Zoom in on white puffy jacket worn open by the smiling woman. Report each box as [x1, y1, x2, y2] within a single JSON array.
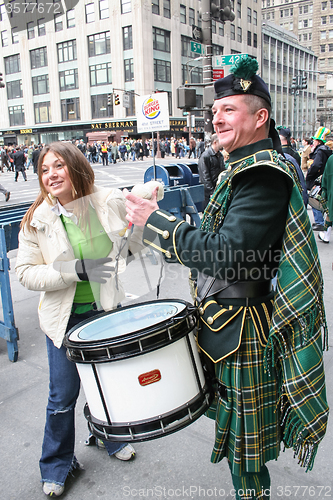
[[15, 188, 143, 348]]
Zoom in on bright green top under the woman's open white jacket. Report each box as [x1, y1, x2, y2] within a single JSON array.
[[60, 205, 112, 304]]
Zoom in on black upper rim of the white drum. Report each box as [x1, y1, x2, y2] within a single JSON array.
[[63, 299, 197, 362]]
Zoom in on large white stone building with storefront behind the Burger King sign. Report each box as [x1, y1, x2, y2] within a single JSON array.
[[0, 0, 261, 144]]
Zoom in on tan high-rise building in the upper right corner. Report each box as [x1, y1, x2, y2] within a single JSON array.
[[262, 0, 333, 130]]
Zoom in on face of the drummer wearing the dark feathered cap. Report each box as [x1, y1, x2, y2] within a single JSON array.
[[212, 95, 267, 153]]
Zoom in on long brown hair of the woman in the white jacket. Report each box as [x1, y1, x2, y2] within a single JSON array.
[[21, 142, 95, 230]]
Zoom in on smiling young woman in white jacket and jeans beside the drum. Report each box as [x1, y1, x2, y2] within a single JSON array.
[[16, 142, 142, 496]]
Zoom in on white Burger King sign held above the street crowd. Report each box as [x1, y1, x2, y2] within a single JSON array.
[[135, 92, 170, 133]]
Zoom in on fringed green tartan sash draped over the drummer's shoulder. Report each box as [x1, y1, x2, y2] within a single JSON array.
[[201, 151, 329, 470]]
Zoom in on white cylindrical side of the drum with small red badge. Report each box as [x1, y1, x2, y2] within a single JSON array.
[[77, 332, 205, 424]]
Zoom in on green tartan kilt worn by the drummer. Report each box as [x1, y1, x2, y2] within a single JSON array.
[[207, 317, 281, 476]]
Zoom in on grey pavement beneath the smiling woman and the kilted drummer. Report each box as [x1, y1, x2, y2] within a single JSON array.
[[0, 220, 333, 500]]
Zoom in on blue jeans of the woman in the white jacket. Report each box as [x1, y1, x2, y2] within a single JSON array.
[[39, 311, 126, 485]]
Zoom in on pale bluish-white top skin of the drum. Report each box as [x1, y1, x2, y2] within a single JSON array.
[[68, 300, 186, 344]]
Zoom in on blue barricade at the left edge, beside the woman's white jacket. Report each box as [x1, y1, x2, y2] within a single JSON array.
[[0, 203, 31, 362]]
